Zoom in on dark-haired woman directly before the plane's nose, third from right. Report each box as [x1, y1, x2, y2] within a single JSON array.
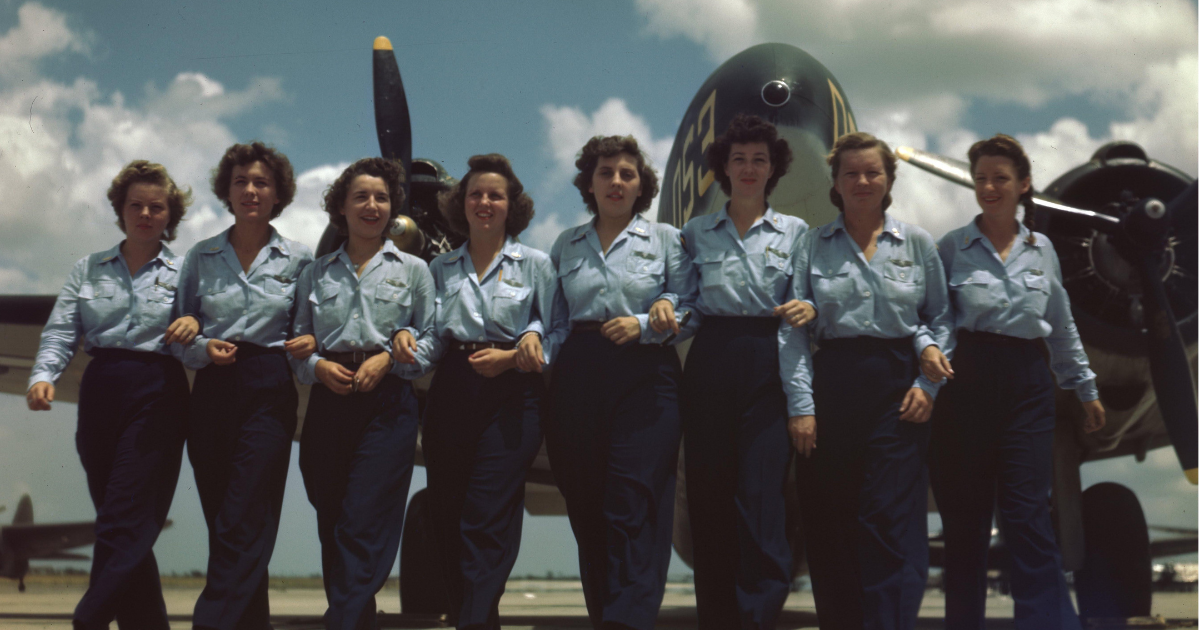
[[680, 114, 808, 630]]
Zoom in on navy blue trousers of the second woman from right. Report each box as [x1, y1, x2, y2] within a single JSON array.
[[796, 337, 930, 630]]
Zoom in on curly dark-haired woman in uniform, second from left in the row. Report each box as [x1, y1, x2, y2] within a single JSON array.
[[179, 142, 312, 630]]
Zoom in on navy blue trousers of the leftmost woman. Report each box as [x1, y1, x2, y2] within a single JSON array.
[[74, 349, 187, 630]]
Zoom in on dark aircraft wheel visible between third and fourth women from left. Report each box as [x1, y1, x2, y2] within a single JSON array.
[[400, 490, 450, 614]]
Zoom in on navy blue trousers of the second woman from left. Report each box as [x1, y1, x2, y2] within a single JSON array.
[[187, 344, 298, 630]]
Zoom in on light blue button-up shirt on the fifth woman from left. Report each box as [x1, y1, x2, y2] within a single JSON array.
[[550, 215, 696, 354]]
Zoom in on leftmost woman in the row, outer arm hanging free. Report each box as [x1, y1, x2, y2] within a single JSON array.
[[25, 160, 196, 630]]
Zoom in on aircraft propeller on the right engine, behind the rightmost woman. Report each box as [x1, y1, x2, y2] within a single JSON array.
[[896, 146, 1198, 485]]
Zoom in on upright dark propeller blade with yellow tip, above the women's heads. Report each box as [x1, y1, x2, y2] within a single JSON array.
[[372, 36, 413, 215]]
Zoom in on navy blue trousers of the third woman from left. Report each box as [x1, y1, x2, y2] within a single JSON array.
[[300, 374, 418, 630]]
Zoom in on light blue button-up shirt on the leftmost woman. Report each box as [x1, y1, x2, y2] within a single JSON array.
[[29, 244, 182, 386]]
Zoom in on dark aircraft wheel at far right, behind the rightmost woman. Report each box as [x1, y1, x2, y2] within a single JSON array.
[[1075, 482, 1151, 619]]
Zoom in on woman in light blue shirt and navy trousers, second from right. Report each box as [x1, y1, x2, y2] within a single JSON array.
[[785, 132, 952, 629]]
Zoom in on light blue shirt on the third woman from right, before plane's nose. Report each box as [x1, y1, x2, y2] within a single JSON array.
[[679, 204, 809, 415]]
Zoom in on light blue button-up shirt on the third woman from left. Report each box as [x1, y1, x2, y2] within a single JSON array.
[[293, 240, 434, 384]]
